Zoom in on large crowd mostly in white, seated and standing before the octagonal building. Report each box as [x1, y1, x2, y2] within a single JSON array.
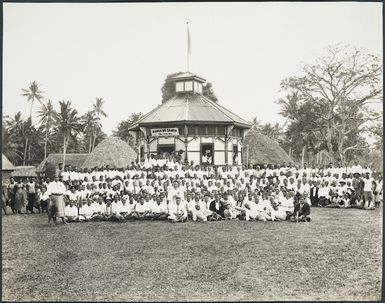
[[3, 155, 383, 223]]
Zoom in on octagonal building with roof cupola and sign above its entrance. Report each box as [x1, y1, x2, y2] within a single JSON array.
[[129, 72, 251, 165]]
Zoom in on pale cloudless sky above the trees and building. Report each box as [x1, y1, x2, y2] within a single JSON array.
[[3, 2, 383, 135]]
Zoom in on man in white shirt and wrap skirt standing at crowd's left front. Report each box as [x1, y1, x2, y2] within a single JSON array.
[[47, 175, 67, 224]]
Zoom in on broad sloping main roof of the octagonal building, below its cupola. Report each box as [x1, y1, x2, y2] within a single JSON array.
[[130, 93, 251, 130]]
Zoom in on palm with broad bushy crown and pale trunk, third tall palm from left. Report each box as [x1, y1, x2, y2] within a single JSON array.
[[54, 101, 80, 167]]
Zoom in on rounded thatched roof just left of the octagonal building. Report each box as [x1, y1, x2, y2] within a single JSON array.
[[82, 137, 137, 168]]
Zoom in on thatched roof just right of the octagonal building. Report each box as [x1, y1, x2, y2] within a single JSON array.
[[242, 132, 293, 164]]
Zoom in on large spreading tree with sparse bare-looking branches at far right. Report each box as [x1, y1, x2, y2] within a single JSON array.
[[278, 46, 382, 162]]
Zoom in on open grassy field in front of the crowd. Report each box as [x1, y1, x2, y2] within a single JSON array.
[[2, 209, 382, 301]]
